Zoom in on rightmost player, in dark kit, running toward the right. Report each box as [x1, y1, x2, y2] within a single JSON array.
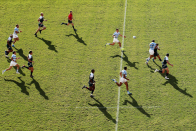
[[154, 53, 173, 80]]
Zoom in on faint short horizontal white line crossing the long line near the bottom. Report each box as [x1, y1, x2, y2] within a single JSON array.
[[76, 106, 160, 109]]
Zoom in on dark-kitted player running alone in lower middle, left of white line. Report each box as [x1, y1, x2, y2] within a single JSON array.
[[82, 69, 95, 98]]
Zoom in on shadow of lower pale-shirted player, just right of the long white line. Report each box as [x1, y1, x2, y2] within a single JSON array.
[[123, 95, 150, 117]]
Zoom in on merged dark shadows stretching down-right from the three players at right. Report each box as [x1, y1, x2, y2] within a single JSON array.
[[148, 62, 193, 98]]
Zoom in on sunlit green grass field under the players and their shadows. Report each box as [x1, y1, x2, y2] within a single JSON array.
[[0, 0, 196, 131]]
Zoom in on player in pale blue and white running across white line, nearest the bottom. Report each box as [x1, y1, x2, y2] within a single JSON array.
[[112, 66, 132, 95]]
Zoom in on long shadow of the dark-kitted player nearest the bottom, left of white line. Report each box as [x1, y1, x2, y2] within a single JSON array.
[[88, 98, 116, 123]]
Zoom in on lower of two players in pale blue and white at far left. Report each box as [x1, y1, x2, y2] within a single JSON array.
[[2, 51, 20, 75]]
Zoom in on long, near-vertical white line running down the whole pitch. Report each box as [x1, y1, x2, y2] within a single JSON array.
[[115, 0, 127, 131]]
